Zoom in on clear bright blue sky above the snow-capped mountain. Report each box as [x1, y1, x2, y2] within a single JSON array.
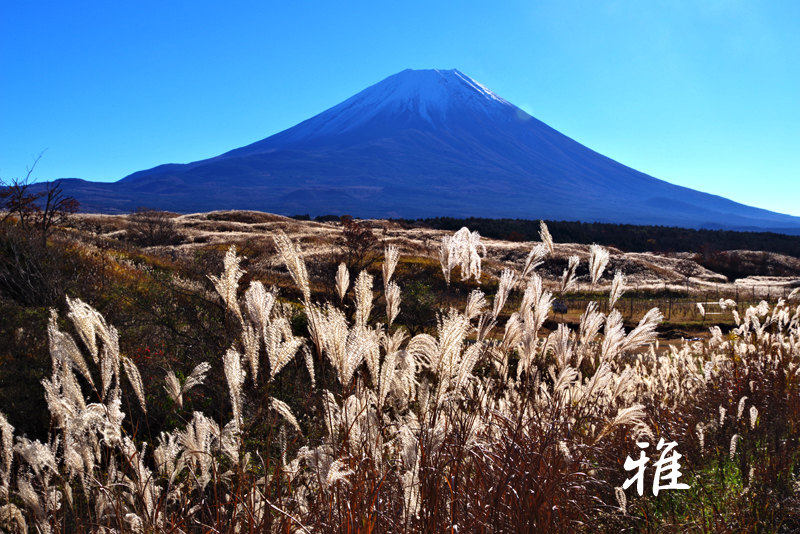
[[0, 0, 800, 216]]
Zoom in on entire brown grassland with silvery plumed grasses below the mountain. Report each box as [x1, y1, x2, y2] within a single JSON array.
[[0, 212, 800, 532]]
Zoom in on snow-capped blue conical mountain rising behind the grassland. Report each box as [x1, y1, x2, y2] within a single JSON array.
[[56, 70, 800, 233]]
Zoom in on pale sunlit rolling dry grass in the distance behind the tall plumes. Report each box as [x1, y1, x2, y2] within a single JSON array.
[[73, 211, 800, 298]]
